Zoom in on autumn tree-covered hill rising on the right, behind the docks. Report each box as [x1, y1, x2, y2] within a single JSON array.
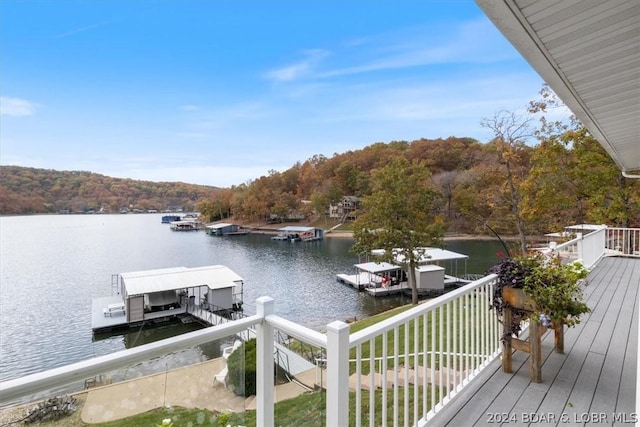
[[198, 86, 640, 241]]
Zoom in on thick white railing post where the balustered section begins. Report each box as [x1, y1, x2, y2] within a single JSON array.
[[326, 321, 349, 426]]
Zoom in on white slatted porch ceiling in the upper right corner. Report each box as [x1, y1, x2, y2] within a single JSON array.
[[475, 0, 640, 175]]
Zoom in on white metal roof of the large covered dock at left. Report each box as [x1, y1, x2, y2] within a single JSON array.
[[120, 265, 242, 295]]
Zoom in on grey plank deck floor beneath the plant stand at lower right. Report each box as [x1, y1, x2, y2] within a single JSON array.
[[429, 258, 640, 427]]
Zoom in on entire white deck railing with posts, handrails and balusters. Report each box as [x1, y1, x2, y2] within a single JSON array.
[[0, 228, 640, 426]]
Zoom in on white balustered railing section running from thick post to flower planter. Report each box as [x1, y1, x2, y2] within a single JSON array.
[[344, 275, 501, 426]]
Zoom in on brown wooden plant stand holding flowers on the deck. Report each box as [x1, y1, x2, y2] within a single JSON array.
[[502, 287, 564, 383]]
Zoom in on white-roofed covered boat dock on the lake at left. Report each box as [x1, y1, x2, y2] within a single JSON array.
[[91, 265, 243, 332]]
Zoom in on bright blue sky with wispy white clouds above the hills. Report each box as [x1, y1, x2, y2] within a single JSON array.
[[0, 0, 542, 187]]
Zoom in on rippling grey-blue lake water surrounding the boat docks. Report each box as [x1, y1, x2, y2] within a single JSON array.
[[0, 214, 510, 381]]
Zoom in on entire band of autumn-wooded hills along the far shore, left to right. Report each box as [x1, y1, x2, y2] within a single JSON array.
[[0, 89, 640, 236]]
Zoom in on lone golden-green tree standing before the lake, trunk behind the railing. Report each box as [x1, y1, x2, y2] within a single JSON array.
[[351, 157, 444, 304]]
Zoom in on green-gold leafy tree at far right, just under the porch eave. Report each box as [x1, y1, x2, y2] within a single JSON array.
[[524, 85, 640, 229]]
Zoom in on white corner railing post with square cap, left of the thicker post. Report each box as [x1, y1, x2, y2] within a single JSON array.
[[256, 297, 274, 427]]
